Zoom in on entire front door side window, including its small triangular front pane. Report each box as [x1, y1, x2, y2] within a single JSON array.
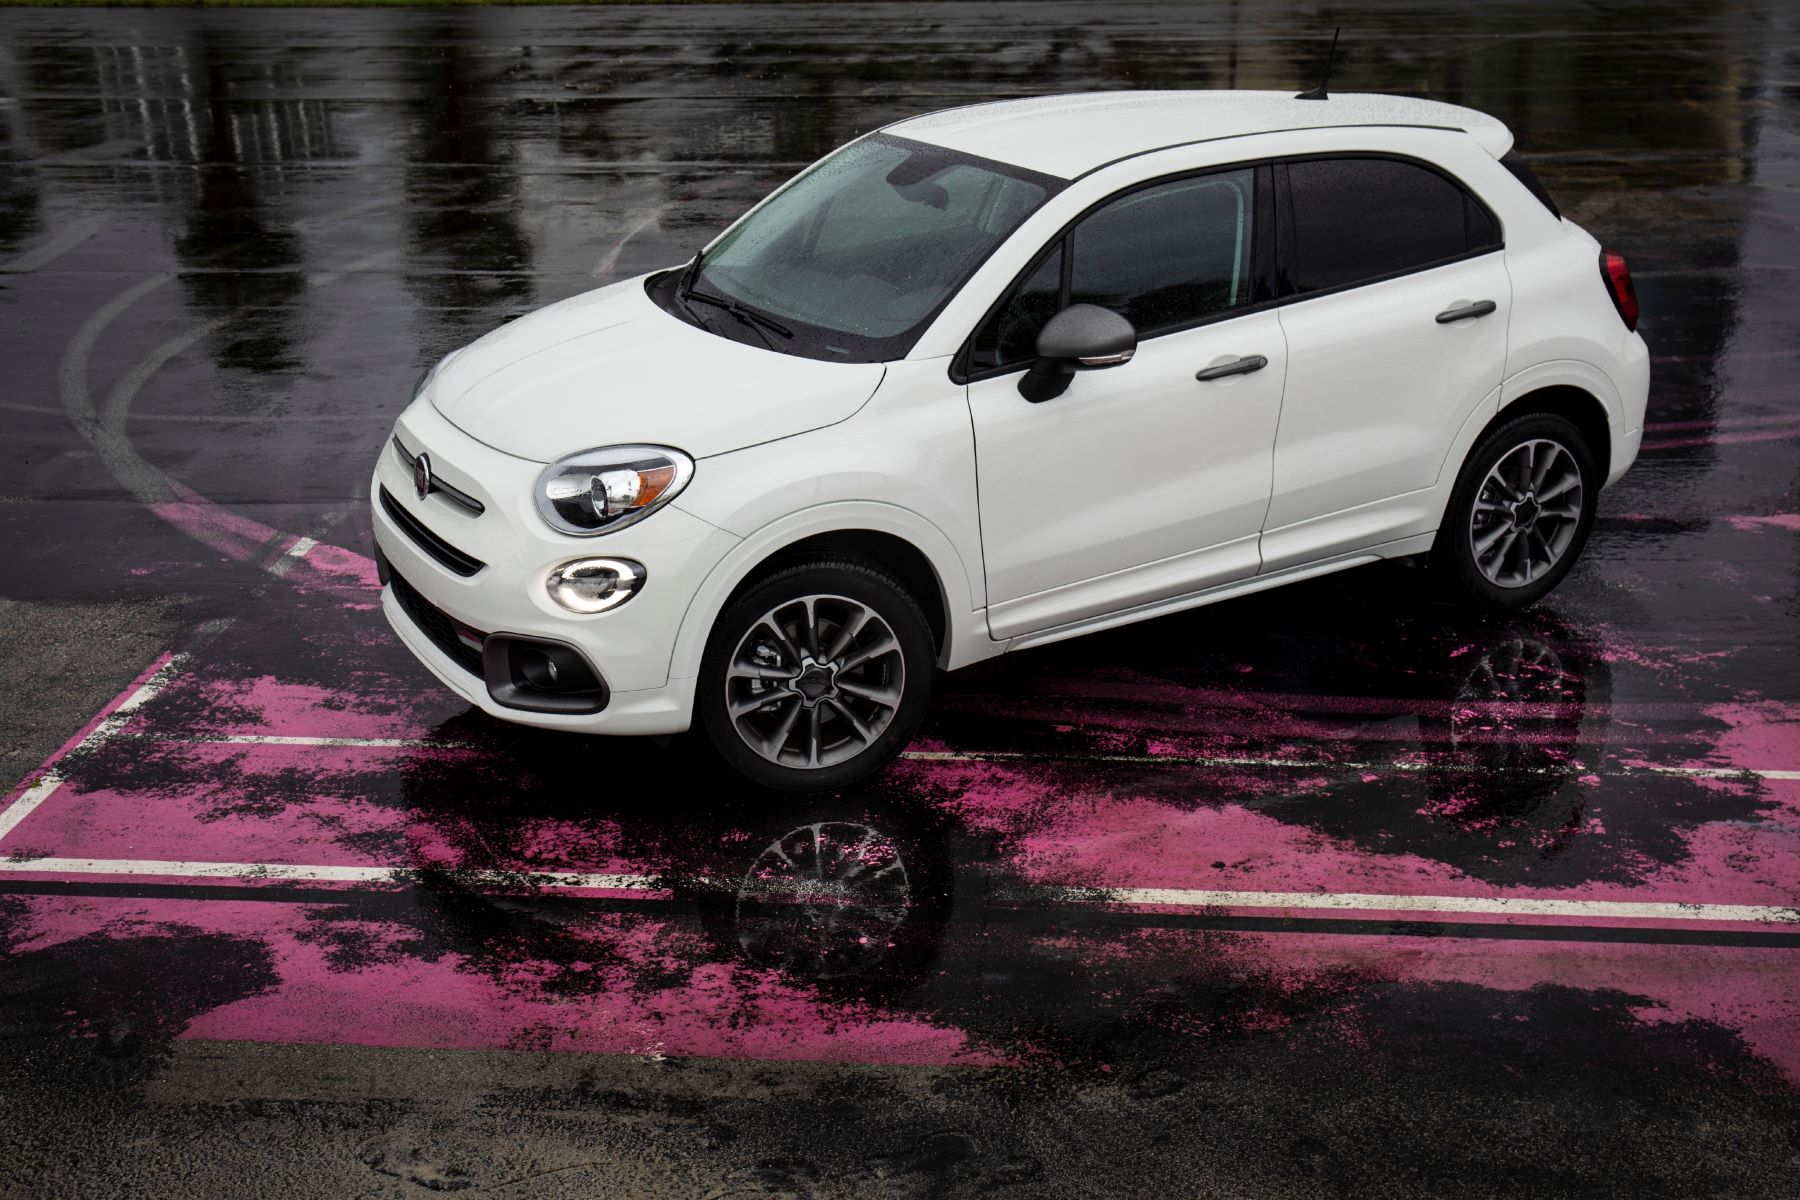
[[968, 169, 1255, 371]]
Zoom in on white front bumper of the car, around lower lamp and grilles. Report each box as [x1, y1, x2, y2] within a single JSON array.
[[371, 399, 738, 734]]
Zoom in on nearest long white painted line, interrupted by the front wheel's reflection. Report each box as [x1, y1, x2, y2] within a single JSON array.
[[0, 858, 1800, 925]]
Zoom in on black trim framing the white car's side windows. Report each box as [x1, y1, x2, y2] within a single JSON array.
[[950, 149, 1507, 385]]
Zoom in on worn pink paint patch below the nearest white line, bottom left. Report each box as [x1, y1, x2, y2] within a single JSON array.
[[14, 898, 1008, 1067]]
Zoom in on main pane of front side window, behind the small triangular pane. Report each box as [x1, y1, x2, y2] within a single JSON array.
[[1069, 171, 1255, 336]]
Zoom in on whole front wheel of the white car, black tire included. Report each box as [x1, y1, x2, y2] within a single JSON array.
[[695, 558, 936, 793]]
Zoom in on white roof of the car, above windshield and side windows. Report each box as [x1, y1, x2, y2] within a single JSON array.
[[887, 92, 1512, 180]]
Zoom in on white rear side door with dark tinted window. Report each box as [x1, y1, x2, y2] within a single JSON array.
[[1262, 155, 1512, 572]]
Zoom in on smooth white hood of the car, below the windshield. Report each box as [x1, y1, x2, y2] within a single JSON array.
[[428, 279, 884, 462]]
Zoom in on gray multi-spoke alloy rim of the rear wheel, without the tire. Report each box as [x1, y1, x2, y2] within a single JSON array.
[[1469, 437, 1584, 588]]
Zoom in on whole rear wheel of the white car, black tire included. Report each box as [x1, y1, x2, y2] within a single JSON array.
[[1431, 412, 1602, 608]]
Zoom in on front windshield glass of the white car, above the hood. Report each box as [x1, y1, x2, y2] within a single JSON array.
[[691, 135, 1058, 362]]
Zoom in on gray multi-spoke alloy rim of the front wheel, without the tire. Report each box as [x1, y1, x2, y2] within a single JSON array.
[[724, 594, 905, 770]]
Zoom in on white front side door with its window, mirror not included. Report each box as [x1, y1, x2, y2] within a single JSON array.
[[968, 167, 1287, 639]]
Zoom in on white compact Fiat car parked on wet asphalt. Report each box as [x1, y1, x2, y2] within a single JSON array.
[[373, 92, 1649, 790]]
